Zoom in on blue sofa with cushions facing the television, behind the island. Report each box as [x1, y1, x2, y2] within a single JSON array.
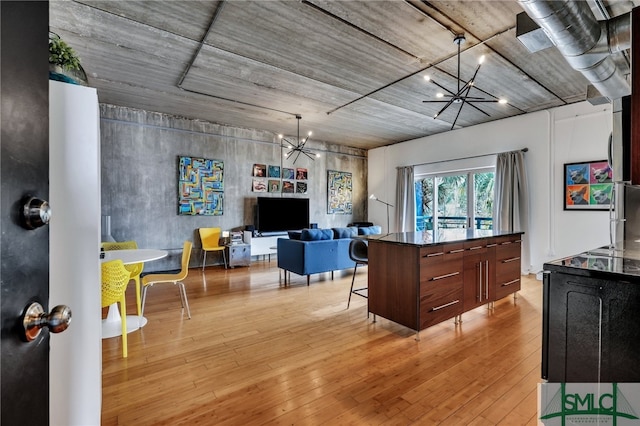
[[278, 226, 381, 285]]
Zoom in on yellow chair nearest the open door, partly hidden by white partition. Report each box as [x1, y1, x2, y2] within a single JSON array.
[[101, 259, 131, 358]]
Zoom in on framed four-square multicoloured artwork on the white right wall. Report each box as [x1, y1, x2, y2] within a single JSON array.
[[564, 160, 613, 210]]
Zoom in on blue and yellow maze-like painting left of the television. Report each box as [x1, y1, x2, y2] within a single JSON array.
[[178, 157, 224, 216]]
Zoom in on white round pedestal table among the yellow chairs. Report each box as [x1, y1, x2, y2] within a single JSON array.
[[100, 249, 169, 339]]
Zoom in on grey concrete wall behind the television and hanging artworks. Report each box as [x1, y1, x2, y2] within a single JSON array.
[[101, 104, 368, 271]]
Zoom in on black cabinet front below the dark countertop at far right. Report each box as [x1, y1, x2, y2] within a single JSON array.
[[542, 265, 640, 383]]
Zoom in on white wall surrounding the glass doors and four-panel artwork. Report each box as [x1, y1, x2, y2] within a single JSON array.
[[368, 102, 612, 273]]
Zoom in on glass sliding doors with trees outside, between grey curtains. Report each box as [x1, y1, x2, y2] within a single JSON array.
[[415, 168, 495, 231]]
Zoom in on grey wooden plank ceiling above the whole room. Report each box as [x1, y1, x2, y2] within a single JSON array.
[[50, 0, 634, 149]]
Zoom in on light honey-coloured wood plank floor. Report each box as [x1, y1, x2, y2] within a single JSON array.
[[102, 260, 542, 426]]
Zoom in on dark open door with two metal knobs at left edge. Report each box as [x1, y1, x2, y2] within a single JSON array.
[[0, 1, 49, 425]]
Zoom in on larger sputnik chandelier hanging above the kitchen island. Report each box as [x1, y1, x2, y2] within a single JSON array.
[[422, 34, 507, 130]]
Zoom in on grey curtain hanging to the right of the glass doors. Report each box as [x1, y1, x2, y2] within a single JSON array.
[[493, 151, 529, 271]]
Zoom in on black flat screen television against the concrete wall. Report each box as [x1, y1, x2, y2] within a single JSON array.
[[256, 197, 309, 233]]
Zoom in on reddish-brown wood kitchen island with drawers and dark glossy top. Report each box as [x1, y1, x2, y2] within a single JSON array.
[[367, 229, 523, 339]]
